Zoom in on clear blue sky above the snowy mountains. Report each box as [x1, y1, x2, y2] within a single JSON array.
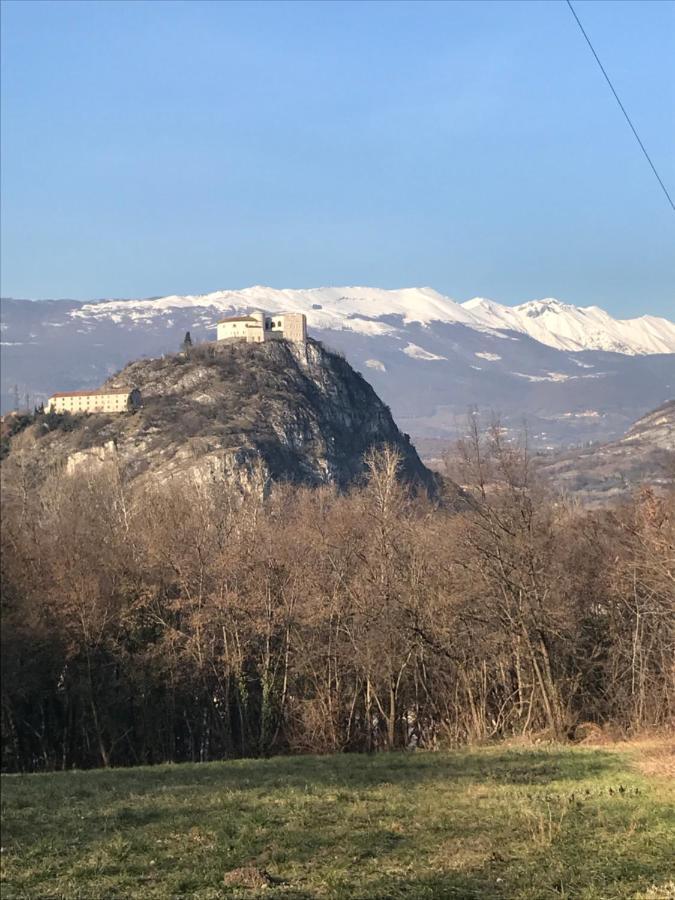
[[2, 0, 675, 318]]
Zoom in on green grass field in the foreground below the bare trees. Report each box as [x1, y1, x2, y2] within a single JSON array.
[[2, 746, 675, 900]]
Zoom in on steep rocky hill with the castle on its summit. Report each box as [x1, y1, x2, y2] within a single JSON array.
[[6, 340, 435, 490]]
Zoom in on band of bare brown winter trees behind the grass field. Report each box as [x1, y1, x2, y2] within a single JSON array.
[[2, 426, 675, 771]]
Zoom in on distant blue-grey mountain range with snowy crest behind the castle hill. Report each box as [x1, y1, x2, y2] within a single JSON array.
[[2, 287, 675, 447]]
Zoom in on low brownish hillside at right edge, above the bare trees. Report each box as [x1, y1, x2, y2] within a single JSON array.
[[539, 400, 675, 506]]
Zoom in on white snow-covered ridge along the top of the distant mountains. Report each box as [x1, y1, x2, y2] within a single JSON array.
[[70, 285, 675, 355]]
